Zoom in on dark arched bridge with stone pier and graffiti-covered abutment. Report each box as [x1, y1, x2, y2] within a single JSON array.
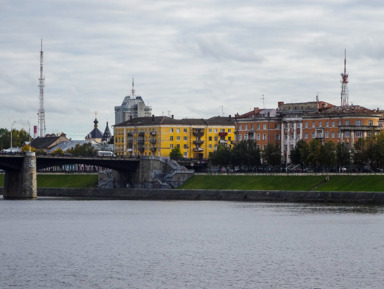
[[0, 152, 193, 199]]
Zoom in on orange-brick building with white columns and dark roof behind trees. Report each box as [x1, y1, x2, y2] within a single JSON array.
[[235, 101, 382, 163]]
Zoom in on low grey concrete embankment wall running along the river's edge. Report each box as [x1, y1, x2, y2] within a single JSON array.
[[32, 188, 384, 205]]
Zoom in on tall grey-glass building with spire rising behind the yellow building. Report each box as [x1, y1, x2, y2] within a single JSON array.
[[115, 80, 152, 124]]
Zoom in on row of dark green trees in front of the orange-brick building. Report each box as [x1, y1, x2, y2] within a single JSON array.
[[209, 134, 384, 171]]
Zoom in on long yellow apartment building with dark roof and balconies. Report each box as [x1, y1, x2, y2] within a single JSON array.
[[114, 116, 235, 159]]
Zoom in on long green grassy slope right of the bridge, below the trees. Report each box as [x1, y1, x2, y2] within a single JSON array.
[[180, 175, 384, 192]]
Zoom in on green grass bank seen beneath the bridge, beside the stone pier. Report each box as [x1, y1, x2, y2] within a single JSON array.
[[0, 174, 98, 188]]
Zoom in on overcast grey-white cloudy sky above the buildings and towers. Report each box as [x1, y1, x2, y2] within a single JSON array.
[[0, 0, 384, 140]]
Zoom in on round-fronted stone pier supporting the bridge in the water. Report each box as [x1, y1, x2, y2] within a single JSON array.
[[3, 152, 37, 199]]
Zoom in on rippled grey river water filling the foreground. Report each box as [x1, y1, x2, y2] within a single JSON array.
[[0, 197, 384, 289]]
